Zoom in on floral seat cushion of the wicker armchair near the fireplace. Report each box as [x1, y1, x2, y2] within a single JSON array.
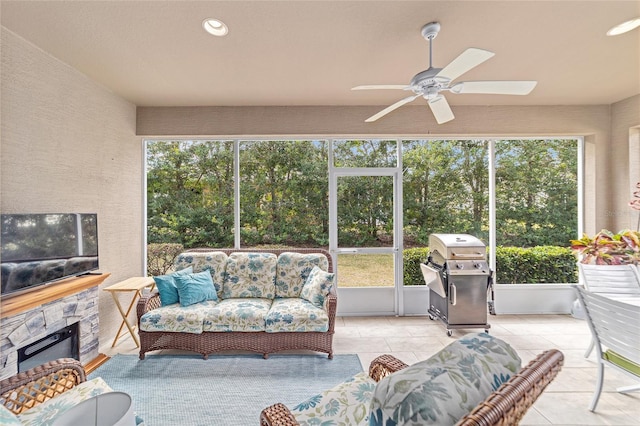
[[18, 377, 113, 426]]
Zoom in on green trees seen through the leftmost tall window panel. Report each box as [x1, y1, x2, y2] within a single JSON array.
[[147, 141, 233, 248]]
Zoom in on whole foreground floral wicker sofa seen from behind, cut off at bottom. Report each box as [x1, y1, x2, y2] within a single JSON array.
[[260, 333, 564, 426]]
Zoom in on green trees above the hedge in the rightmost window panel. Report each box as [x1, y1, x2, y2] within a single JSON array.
[[496, 140, 578, 247]]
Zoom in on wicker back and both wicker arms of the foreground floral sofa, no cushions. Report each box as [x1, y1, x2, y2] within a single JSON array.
[[260, 349, 564, 426]]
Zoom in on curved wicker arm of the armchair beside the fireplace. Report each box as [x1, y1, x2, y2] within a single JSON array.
[[0, 358, 87, 414]]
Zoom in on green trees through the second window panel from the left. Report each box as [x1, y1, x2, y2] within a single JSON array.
[[240, 141, 329, 246]]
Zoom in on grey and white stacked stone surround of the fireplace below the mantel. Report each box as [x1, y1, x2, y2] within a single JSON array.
[[0, 286, 99, 380]]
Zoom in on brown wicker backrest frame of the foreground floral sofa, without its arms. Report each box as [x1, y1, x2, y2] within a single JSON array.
[[456, 349, 564, 426]]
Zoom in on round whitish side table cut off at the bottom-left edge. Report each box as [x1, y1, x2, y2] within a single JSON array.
[[53, 392, 136, 426]]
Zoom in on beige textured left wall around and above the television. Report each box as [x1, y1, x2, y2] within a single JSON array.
[[0, 27, 143, 352]]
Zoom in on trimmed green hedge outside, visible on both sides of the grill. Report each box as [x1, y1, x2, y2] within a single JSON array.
[[402, 246, 578, 285]]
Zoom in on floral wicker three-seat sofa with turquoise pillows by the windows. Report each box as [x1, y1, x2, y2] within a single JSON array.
[[137, 249, 337, 359]]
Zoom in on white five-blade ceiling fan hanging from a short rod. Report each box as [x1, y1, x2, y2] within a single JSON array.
[[351, 22, 538, 124]]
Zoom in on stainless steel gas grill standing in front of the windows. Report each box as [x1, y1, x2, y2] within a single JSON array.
[[420, 234, 493, 336]]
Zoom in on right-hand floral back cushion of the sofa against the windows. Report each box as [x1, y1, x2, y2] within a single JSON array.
[[276, 252, 329, 297]]
